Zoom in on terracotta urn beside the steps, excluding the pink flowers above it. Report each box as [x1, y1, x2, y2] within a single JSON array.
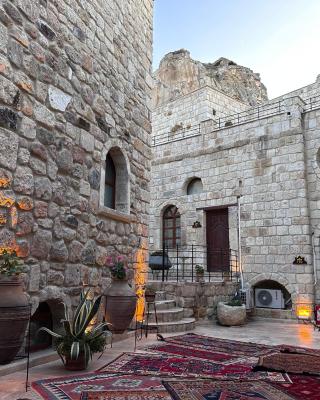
[[105, 279, 137, 333]]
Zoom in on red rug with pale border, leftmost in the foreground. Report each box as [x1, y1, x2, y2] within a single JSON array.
[[32, 372, 170, 400]]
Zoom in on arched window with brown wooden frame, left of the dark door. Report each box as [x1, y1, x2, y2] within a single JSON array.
[[163, 206, 181, 247]]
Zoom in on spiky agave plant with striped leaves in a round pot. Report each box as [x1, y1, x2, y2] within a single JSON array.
[[38, 289, 111, 371]]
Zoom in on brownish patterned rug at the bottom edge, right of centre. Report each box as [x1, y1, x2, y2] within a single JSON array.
[[163, 380, 294, 400]]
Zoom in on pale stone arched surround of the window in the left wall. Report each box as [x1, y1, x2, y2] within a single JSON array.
[[100, 139, 131, 214]]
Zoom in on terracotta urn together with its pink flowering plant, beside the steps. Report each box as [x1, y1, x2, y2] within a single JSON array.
[[105, 256, 137, 333]]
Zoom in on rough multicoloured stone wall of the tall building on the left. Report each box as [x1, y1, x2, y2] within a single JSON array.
[[0, 0, 153, 309]]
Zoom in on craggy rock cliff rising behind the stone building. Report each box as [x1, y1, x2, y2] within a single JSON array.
[[153, 49, 268, 107]]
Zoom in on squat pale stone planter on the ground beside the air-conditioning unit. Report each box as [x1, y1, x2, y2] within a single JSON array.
[[217, 299, 247, 326]]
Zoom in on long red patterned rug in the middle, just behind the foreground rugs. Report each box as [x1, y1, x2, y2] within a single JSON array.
[[100, 353, 290, 382]]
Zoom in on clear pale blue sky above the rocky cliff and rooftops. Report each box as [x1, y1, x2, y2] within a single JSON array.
[[154, 0, 320, 98]]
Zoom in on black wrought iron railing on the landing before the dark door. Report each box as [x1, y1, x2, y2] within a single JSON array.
[[148, 245, 240, 282]]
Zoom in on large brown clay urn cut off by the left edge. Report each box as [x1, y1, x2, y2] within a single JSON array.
[[0, 275, 30, 364]]
